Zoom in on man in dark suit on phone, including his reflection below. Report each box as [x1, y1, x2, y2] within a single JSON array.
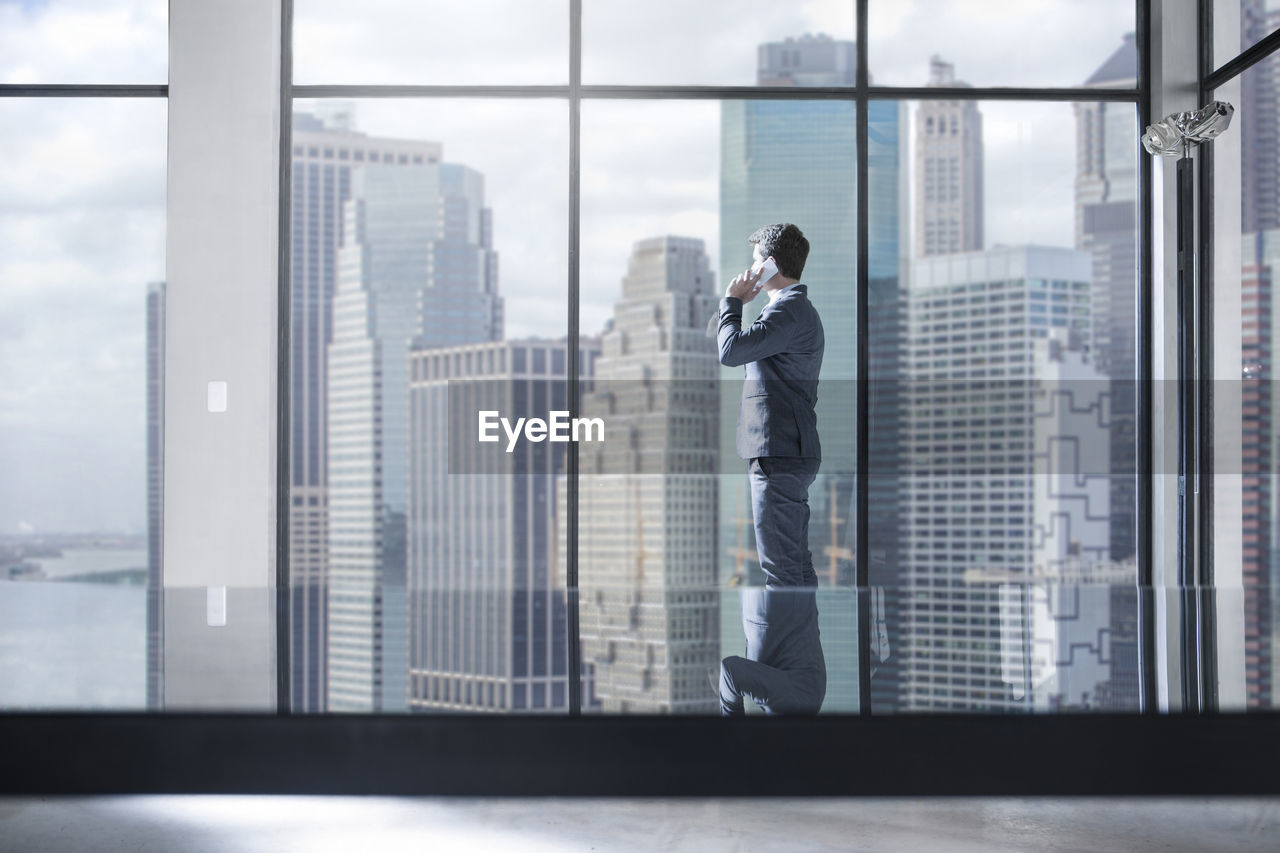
[[716, 224, 827, 716]]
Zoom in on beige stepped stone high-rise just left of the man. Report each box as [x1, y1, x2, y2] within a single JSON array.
[[576, 237, 721, 713]]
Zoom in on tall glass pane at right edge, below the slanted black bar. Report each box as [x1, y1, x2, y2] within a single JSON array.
[[1213, 54, 1280, 710]]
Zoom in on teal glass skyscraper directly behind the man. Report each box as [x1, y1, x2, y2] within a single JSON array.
[[719, 35, 908, 711]]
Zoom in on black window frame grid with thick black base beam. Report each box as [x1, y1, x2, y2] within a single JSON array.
[[10, 0, 1280, 795]]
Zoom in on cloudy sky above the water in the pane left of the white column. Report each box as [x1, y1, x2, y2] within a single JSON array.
[[0, 94, 166, 530]]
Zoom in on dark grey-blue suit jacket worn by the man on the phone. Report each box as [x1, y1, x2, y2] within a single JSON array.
[[708, 284, 826, 459]]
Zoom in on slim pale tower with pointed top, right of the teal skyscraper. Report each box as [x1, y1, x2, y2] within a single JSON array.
[[915, 55, 983, 255]]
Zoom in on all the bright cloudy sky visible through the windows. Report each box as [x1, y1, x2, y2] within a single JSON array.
[[0, 0, 1134, 534]]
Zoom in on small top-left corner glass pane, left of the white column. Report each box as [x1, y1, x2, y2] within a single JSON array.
[[0, 0, 169, 83]]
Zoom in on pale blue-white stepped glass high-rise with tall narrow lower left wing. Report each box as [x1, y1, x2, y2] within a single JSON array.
[[326, 154, 502, 711]]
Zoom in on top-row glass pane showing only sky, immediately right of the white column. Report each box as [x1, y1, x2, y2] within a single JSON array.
[[293, 0, 568, 86]]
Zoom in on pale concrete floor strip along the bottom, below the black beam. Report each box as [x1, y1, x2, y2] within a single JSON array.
[[0, 795, 1280, 853]]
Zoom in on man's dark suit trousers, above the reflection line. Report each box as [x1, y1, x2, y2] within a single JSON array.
[[748, 456, 822, 587]]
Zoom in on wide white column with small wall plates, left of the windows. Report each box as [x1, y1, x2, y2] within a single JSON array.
[[164, 0, 280, 710]]
